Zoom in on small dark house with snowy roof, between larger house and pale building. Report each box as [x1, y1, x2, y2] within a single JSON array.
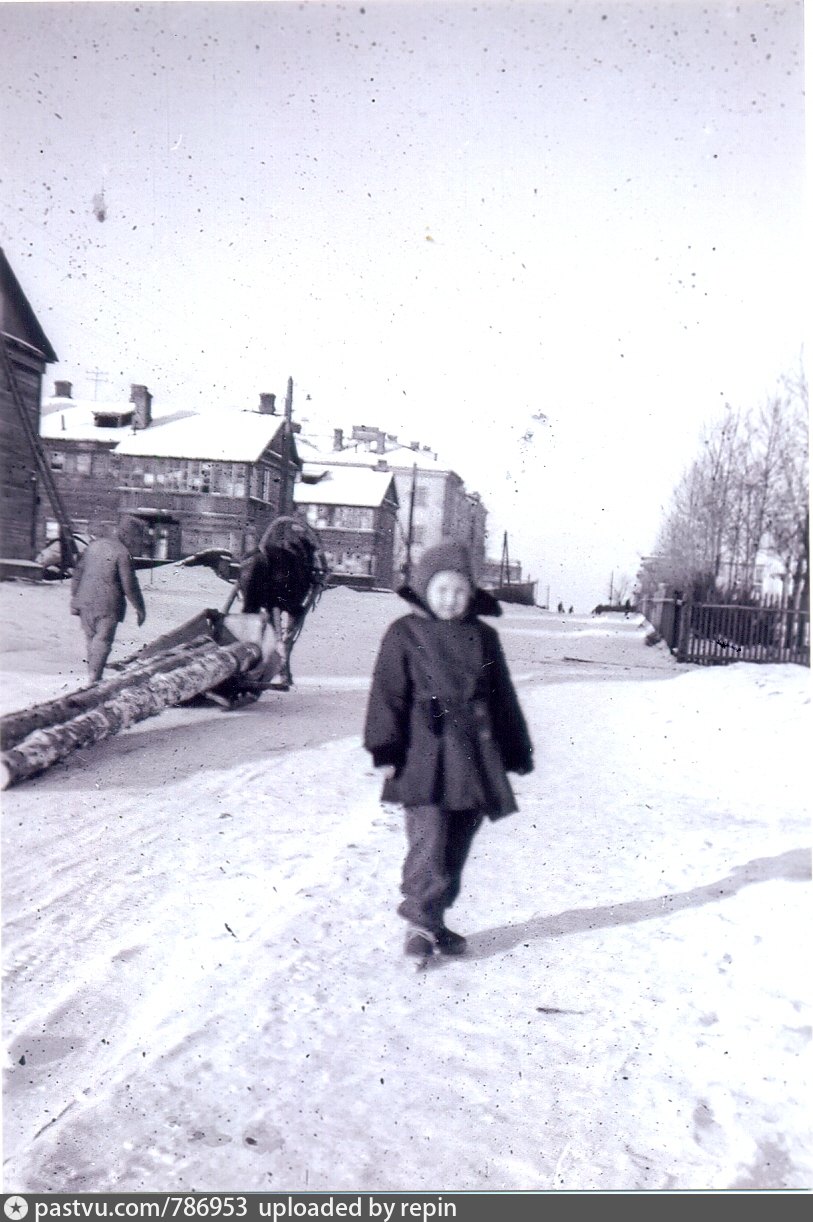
[[293, 464, 399, 588]]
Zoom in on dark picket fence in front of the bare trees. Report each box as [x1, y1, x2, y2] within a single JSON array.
[[638, 594, 811, 666]]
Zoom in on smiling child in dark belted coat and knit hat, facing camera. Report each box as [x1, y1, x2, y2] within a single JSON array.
[[364, 540, 533, 957]]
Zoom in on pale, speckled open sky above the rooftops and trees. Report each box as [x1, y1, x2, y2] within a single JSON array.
[[0, 0, 807, 610]]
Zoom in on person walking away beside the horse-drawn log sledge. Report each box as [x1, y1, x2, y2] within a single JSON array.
[[71, 517, 147, 683]]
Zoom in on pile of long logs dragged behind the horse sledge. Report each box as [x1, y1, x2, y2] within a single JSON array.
[[0, 635, 260, 789]]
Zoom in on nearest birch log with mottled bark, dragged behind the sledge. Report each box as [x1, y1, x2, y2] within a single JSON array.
[[0, 642, 260, 789]]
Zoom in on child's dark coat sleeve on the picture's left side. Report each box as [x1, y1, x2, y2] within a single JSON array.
[[364, 622, 412, 769]]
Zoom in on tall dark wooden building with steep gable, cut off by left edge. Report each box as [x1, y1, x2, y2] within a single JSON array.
[[0, 249, 56, 561]]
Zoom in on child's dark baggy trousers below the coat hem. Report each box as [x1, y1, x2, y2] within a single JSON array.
[[399, 807, 483, 932]]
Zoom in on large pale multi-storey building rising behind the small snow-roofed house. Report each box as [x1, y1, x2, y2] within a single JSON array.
[[301, 424, 488, 579]]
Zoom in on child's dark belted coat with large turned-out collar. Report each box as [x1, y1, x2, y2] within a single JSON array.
[[364, 587, 533, 819]]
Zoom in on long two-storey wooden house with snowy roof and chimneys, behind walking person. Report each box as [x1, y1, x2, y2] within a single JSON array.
[[40, 384, 301, 560]]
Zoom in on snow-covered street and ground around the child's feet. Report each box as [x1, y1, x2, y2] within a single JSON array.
[[0, 569, 813, 1193]]
